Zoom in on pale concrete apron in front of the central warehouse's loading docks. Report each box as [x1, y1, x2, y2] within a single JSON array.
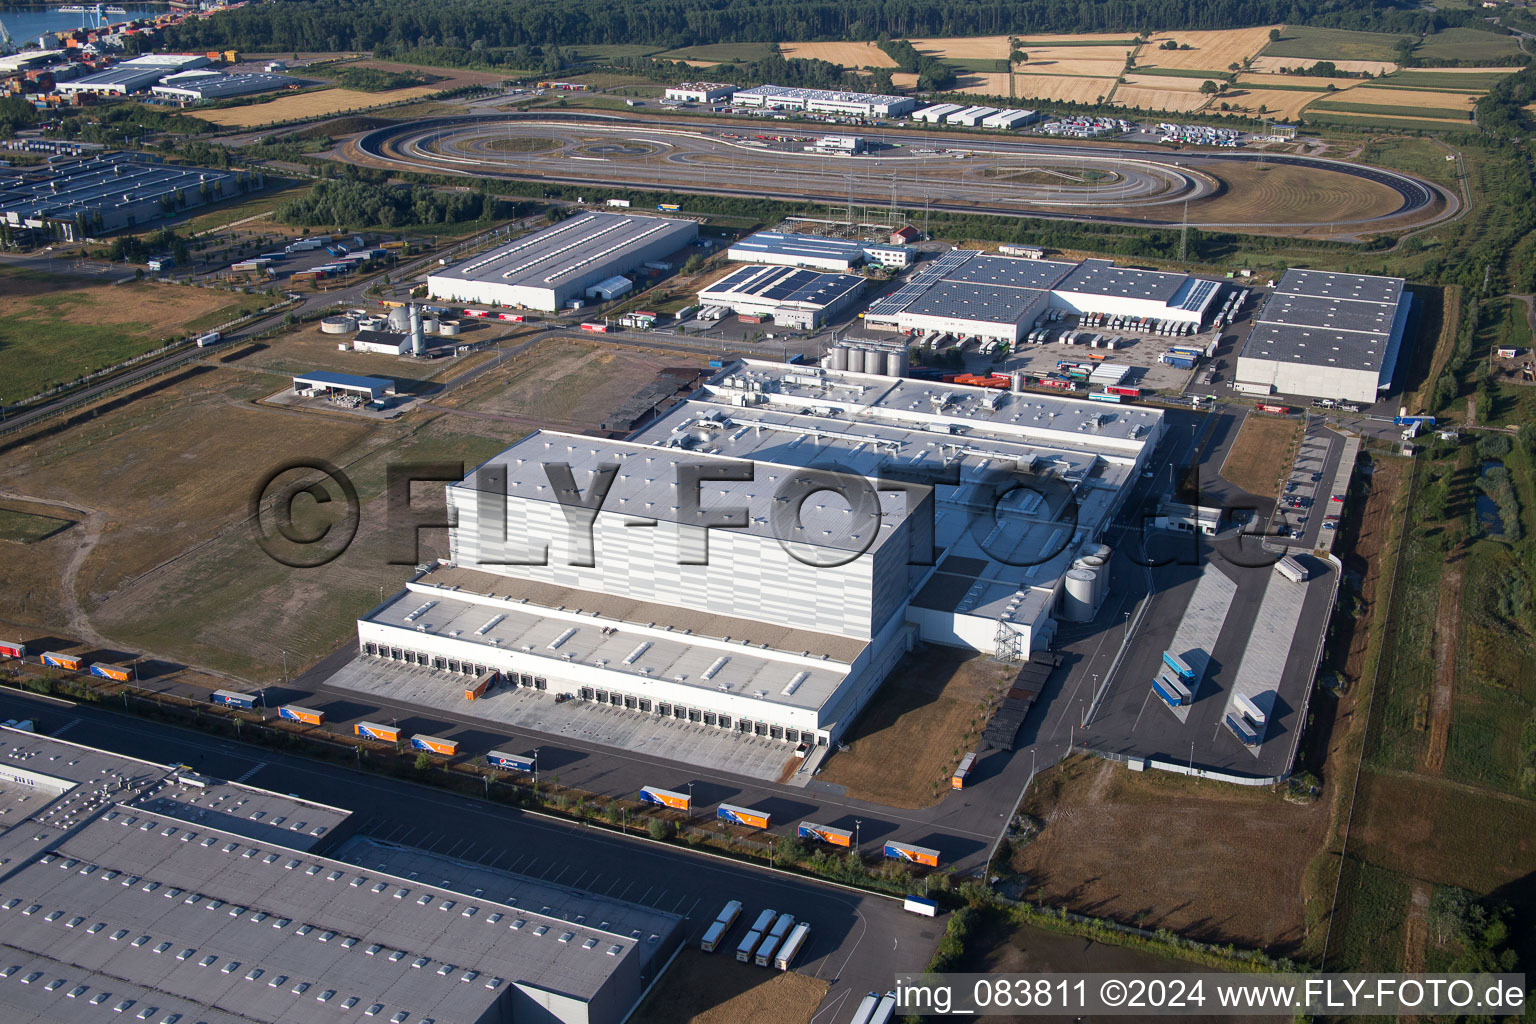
[[326, 659, 793, 781]]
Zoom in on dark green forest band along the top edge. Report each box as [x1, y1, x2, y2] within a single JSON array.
[[166, 0, 1481, 52]]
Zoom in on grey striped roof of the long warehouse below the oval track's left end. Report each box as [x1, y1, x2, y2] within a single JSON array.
[[432, 213, 699, 289]]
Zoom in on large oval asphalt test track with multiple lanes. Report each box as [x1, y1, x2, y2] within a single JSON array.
[[353, 114, 1459, 227]]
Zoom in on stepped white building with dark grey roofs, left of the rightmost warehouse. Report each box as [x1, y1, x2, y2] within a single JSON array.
[[865, 249, 1221, 344]]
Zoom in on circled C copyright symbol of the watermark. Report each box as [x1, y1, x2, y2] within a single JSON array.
[[250, 459, 362, 570]]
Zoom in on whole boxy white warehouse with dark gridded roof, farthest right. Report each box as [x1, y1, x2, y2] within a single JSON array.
[[1236, 270, 1412, 402]]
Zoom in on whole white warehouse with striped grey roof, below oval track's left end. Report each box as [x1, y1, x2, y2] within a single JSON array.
[[427, 213, 699, 312]]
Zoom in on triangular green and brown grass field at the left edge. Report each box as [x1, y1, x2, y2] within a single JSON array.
[[0, 270, 254, 402]]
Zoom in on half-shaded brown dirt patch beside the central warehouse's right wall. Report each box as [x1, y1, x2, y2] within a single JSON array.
[[817, 645, 1018, 808]]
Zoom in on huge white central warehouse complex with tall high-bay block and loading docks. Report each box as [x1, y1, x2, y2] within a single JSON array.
[[344, 361, 1163, 745]]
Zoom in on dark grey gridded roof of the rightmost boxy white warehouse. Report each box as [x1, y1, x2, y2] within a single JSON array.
[[1240, 270, 1407, 376]]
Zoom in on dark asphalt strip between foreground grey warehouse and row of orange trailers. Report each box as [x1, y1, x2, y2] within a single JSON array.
[[0, 688, 945, 1024]]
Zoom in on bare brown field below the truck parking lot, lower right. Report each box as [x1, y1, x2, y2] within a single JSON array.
[[1012, 757, 1327, 953]]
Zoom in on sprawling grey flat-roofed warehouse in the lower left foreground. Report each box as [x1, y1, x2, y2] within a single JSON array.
[[0, 728, 682, 1024]]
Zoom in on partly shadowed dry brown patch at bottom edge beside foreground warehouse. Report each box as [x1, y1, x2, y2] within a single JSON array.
[[630, 946, 831, 1024]]
